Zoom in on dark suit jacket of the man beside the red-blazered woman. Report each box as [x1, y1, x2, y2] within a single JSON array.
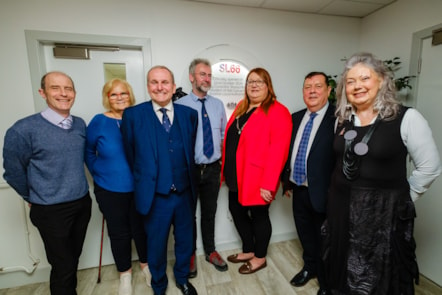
[[281, 104, 336, 213]]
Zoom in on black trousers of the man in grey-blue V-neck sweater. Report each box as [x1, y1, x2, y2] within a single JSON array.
[[30, 193, 92, 295]]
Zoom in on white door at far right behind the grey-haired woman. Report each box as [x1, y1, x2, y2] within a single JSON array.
[[415, 38, 442, 285]]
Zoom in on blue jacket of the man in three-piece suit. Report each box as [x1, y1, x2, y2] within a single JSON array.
[[121, 101, 198, 215]]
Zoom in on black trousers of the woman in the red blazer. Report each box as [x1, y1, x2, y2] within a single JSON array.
[[229, 191, 272, 258]]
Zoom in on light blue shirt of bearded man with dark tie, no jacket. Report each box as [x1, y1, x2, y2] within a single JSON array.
[[175, 92, 227, 164]]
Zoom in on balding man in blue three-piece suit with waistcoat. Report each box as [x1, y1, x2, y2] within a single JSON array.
[[121, 66, 198, 295]]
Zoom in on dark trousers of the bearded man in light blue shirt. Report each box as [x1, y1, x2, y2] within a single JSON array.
[[193, 161, 221, 254]]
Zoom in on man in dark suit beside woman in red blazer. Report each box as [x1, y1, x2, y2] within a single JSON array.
[[282, 72, 335, 295]]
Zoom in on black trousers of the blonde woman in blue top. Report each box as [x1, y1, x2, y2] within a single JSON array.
[[94, 183, 147, 272]]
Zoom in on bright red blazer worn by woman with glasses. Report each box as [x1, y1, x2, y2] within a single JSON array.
[[221, 101, 292, 206]]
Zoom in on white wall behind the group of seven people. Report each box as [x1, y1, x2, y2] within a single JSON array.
[[0, 0, 442, 288]]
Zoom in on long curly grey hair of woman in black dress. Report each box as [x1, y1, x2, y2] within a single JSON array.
[[335, 52, 401, 123]]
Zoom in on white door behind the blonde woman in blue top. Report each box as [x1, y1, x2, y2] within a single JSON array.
[[44, 45, 146, 269]]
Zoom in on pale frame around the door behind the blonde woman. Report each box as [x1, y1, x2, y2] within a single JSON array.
[[25, 30, 152, 112]]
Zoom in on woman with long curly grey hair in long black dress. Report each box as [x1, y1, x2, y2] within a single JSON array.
[[323, 53, 441, 295]]
